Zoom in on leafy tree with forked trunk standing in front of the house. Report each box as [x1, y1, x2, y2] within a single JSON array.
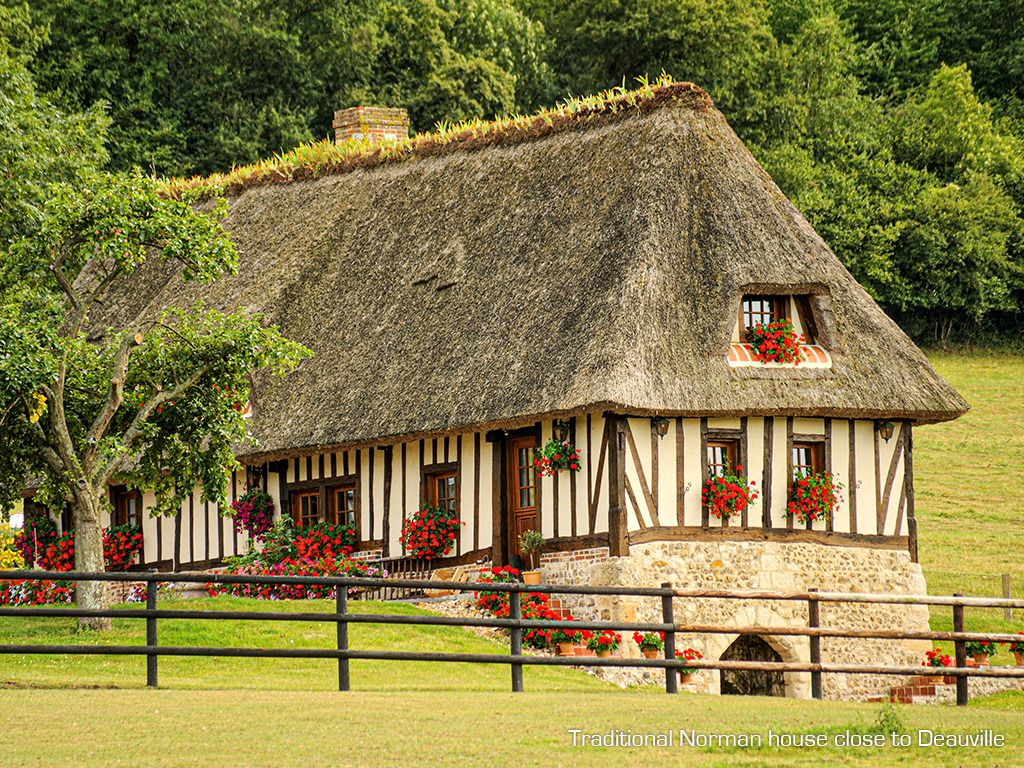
[[0, 173, 308, 629]]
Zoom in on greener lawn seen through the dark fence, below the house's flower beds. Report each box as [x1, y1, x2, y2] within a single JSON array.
[[0, 597, 609, 696]]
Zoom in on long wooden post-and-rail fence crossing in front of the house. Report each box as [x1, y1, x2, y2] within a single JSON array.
[[0, 568, 1024, 706]]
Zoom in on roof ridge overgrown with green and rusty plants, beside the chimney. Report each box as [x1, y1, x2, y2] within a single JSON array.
[[164, 72, 714, 203]]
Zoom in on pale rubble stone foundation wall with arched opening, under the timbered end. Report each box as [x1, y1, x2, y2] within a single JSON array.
[[543, 542, 931, 700]]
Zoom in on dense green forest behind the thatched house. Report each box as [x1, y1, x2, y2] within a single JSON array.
[[0, 0, 1024, 346]]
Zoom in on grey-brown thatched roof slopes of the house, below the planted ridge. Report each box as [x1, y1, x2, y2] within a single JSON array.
[[90, 82, 968, 457]]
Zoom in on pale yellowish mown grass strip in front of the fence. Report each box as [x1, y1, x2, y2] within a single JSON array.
[[0, 683, 1024, 768]]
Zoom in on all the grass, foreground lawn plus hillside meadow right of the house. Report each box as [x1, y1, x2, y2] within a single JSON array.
[[0, 353, 1024, 768]]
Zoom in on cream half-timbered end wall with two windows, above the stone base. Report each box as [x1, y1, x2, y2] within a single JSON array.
[[622, 417, 912, 538]]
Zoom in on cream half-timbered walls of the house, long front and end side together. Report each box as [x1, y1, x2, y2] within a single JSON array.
[[253, 414, 913, 559]]
